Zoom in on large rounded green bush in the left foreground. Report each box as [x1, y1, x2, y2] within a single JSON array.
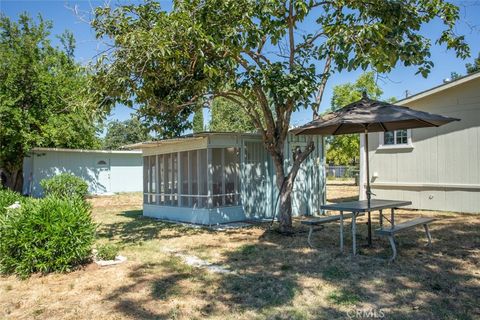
[[0, 197, 96, 278]]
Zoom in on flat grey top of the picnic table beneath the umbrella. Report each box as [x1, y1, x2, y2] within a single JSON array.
[[320, 199, 412, 212]]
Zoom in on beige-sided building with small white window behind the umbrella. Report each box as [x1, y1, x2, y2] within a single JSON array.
[[360, 73, 480, 213]]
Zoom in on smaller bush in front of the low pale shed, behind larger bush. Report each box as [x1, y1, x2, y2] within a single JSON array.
[[40, 173, 88, 199]]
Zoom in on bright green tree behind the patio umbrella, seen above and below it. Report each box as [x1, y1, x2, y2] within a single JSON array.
[[327, 72, 395, 165]]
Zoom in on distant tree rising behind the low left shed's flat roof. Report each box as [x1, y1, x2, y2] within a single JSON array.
[[103, 117, 152, 150]]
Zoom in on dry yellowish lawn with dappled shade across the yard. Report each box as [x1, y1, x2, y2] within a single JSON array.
[[0, 183, 480, 319]]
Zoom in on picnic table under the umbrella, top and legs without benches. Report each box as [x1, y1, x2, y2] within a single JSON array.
[[320, 199, 412, 256]]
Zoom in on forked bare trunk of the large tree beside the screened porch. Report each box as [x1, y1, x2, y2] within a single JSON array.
[[272, 141, 315, 233]]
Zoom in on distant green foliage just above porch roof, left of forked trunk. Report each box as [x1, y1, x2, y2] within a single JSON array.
[[209, 98, 256, 132]]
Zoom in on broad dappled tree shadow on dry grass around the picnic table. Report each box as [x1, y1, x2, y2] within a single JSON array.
[[103, 211, 480, 319]]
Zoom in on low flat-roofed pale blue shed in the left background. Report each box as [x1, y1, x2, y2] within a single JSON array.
[[23, 148, 142, 197]]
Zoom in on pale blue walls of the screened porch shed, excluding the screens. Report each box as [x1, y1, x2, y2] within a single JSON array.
[[144, 134, 325, 225]]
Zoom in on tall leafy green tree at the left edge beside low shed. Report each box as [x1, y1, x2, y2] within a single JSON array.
[[0, 14, 99, 191]]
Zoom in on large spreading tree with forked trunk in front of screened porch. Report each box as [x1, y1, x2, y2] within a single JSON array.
[[92, 0, 468, 231]]
